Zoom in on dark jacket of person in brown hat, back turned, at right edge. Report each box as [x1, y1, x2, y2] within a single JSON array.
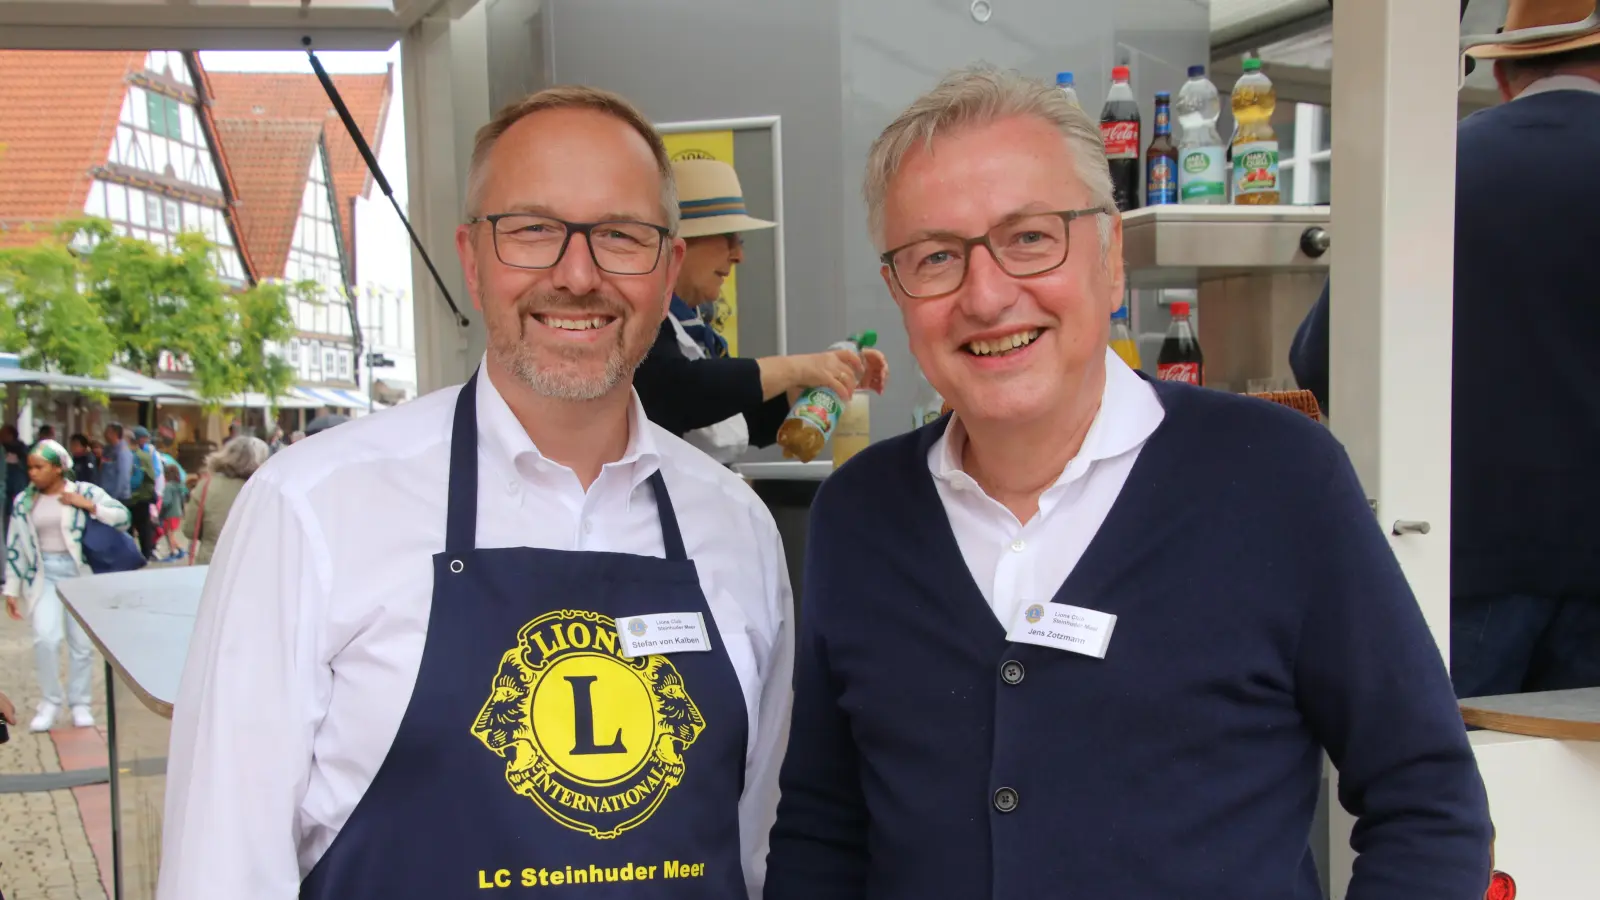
[[1290, 91, 1600, 597]]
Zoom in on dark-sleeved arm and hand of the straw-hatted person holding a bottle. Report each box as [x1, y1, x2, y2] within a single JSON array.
[[634, 320, 864, 445]]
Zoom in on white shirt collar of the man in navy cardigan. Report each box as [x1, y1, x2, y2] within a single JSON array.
[[928, 348, 1166, 496]]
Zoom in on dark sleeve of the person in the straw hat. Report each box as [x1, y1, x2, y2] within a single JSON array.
[[634, 320, 789, 447]]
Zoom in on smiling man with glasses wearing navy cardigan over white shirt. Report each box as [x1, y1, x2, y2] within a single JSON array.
[[765, 69, 1490, 900]]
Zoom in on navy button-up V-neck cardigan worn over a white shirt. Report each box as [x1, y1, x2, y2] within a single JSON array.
[[765, 383, 1490, 900]]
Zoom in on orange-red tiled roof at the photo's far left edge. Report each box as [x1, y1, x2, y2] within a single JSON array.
[[0, 50, 146, 245]]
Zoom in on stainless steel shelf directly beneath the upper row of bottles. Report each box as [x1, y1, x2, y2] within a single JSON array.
[[1122, 205, 1333, 288]]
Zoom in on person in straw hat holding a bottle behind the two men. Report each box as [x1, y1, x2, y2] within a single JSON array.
[[634, 159, 888, 463]]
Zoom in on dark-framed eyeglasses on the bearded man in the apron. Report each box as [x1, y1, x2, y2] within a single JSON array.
[[467, 213, 672, 275]]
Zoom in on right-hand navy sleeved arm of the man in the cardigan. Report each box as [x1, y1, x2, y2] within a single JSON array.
[[1294, 439, 1493, 900]]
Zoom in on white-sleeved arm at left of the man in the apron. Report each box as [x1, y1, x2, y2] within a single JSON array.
[[157, 469, 331, 900]]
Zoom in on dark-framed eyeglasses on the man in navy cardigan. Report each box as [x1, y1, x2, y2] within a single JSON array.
[[882, 207, 1110, 299]]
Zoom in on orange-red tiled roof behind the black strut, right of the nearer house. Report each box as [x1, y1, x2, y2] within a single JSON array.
[[206, 72, 394, 279]]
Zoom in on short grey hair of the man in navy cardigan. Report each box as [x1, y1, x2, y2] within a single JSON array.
[[861, 62, 1117, 259]]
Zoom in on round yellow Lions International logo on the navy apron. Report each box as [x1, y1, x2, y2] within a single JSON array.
[[472, 610, 706, 839]]
